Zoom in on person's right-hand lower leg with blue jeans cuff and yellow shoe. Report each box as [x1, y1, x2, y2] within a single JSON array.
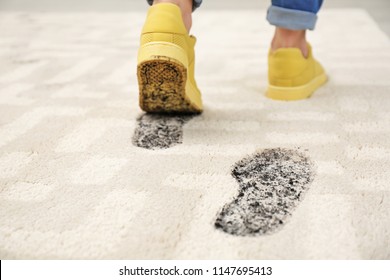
[[267, 0, 327, 100]]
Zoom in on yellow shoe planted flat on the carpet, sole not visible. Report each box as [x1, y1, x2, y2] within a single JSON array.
[[266, 45, 327, 100]]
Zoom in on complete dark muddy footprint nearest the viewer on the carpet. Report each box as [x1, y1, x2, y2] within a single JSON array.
[[215, 148, 314, 236]]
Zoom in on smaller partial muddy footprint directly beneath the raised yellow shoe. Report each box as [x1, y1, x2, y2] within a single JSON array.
[[132, 114, 194, 150]]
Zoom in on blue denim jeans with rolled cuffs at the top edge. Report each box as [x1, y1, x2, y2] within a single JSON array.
[[147, 0, 323, 30]]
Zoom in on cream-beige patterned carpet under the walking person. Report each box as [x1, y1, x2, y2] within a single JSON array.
[[0, 10, 390, 259]]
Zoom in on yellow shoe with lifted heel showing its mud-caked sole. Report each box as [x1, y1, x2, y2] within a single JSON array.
[[137, 3, 203, 113]]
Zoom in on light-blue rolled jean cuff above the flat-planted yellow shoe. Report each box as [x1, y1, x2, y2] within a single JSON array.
[[267, 6, 317, 30]]
